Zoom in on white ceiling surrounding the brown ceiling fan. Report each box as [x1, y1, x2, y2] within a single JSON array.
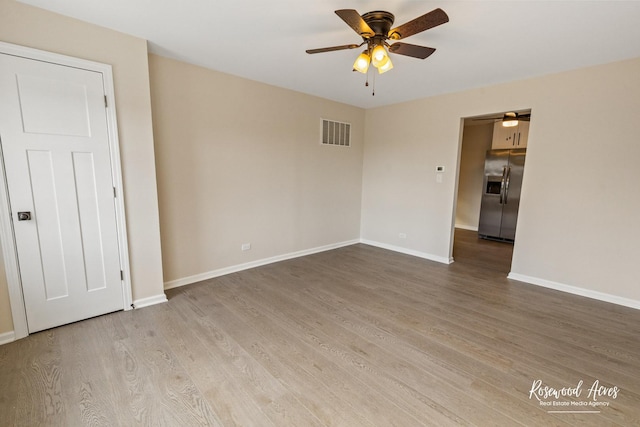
[[20, 0, 640, 108]]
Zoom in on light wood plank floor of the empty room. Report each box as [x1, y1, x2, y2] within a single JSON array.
[[0, 230, 640, 426]]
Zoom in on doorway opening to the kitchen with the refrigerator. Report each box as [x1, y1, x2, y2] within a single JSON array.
[[451, 109, 531, 275]]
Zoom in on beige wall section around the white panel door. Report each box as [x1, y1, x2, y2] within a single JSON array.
[[0, 0, 163, 333]]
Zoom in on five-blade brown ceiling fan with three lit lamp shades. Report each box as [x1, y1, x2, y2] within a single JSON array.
[[306, 8, 449, 74]]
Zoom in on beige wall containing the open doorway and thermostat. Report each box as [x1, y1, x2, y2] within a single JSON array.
[[362, 59, 640, 301]]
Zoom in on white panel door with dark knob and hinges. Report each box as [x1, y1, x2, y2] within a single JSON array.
[[0, 54, 124, 332]]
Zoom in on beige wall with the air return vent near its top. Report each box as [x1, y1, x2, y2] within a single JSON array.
[[149, 55, 364, 286]]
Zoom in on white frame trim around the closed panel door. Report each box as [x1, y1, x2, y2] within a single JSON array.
[[0, 42, 132, 339]]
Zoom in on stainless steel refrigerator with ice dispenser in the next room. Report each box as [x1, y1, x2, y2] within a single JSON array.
[[478, 149, 527, 242]]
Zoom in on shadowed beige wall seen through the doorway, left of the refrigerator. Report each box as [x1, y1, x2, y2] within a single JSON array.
[[455, 121, 493, 230]]
